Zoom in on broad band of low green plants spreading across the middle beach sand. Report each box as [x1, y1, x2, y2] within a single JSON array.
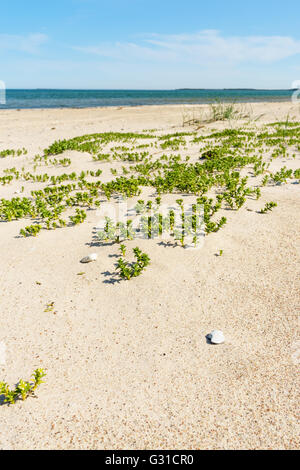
[[0, 126, 300, 246]]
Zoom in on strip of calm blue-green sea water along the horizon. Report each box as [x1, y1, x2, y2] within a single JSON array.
[[0, 89, 292, 109]]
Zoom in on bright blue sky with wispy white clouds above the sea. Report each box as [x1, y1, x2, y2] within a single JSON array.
[[0, 0, 300, 90]]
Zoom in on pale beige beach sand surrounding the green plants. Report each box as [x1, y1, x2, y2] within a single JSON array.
[[0, 103, 300, 449]]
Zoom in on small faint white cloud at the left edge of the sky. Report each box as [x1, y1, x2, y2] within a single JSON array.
[[0, 33, 48, 54]]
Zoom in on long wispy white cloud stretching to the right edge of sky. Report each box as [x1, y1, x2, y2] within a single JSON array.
[[74, 30, 300, 65]]
